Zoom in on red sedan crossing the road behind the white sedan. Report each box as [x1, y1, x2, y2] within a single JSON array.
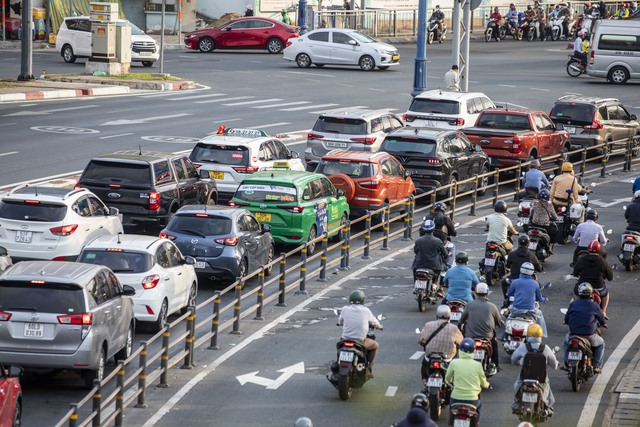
[[184, 16, 300, 53]]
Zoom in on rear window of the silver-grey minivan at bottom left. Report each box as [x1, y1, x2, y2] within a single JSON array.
[[0, 280, 85, 314]]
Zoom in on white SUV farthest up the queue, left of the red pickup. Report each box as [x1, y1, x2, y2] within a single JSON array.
[[403, 89, 496, 130]]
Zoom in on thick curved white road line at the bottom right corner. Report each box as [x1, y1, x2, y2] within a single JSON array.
[[578, 320, 640, 427]]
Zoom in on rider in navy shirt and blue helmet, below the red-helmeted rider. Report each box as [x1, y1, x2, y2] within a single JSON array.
[[562, 282, 607, 374]]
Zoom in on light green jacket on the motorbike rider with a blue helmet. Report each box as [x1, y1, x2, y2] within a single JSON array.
[[445, 351, 489, 400]]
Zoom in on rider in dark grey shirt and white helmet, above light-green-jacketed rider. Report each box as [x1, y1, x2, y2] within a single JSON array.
[[458, 283, 504, 371]]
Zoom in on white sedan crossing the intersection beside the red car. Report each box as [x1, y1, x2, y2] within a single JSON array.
[[284, 28, 400, 71]]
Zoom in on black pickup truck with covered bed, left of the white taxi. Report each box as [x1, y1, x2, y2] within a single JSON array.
[[78, 151, 218, 229]]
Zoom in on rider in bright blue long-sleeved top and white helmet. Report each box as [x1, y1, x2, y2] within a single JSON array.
[[507, 262, 547, 338]]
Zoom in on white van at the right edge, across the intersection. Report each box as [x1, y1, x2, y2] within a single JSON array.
[[587, 19, 640, 84]]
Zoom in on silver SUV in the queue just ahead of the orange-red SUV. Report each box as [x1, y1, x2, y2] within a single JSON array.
[[304, 110, 404, 171]]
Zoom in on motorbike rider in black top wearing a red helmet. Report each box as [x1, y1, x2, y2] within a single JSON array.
[[573, 240, 613, 319]]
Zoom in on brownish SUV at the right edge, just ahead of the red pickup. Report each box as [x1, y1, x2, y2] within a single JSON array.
[[549, 95, 640, 150]]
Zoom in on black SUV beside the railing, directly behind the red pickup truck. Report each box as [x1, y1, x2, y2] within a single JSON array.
[[380, 127, 489, 196]]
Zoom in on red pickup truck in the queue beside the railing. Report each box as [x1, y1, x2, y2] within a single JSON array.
[[462, 109, 571, 168]]
